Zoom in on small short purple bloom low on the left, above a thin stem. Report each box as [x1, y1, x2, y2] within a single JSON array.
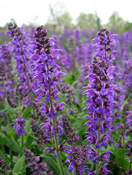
[[11, 116, 26, 136]]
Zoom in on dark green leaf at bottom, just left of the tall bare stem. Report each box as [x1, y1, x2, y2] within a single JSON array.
[[40, 154, 60, 175]]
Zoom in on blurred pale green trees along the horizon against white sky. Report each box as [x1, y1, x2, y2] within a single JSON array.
[[0, 3, 132, 40]]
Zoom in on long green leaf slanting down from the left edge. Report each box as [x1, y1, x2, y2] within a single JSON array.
[[0, 133, 22, 153]]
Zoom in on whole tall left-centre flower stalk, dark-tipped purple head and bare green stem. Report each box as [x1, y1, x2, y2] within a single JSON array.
[[31, 26, 64, 175]]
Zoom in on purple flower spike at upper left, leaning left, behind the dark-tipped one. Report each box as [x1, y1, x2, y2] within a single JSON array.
[[7, 23, 35, 107]]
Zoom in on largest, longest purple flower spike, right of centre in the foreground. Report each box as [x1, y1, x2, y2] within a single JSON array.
[[85, 29, 116, 174]]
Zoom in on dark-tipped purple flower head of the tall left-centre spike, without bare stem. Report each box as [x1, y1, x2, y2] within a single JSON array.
[[32, 26, 64, 118]]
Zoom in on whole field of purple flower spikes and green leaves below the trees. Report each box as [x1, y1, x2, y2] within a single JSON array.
[[0, 23, 132, 175]]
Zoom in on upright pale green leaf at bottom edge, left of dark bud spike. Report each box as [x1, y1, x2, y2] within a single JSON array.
[[13, 156, 26, 175]]
